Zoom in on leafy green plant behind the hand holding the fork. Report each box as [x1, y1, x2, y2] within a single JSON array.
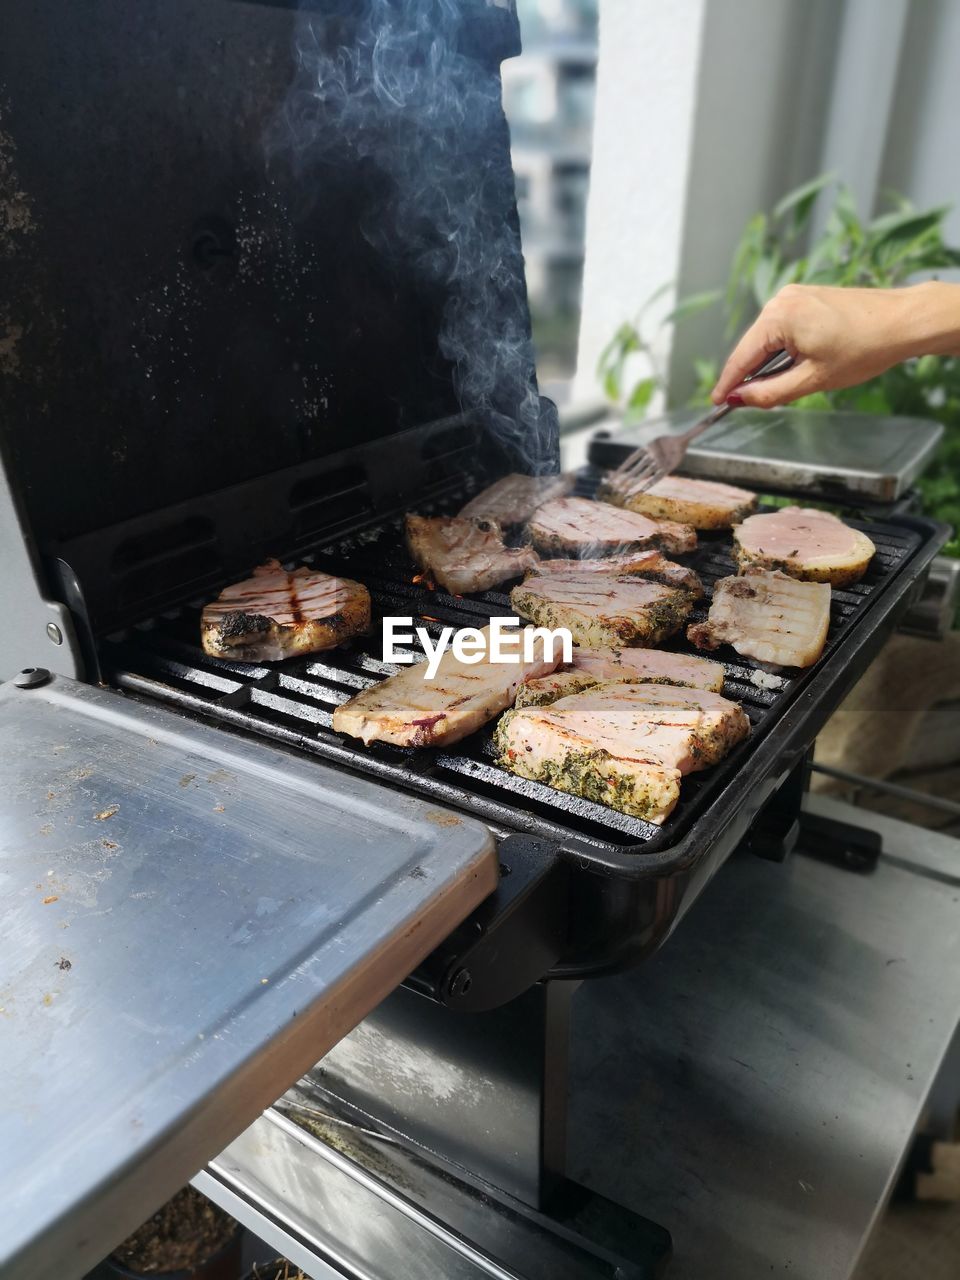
[[600, 174, 960, 557]]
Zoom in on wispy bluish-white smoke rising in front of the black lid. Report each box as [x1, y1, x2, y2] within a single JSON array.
[[270, 0, 552, 470]]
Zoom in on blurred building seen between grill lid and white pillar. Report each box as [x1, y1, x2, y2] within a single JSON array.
[[503, 0, 598, 398]]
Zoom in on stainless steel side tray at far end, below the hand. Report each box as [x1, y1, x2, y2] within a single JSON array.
[[590, 410, 943, 502]]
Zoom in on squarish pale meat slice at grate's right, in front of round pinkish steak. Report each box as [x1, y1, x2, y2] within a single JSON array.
[[686, 568, 831, 667]]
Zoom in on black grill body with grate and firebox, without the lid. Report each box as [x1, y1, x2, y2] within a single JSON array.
[[96, 452, 942, 983]]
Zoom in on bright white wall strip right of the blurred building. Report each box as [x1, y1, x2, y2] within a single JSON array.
[[575, 0, 707, 398]]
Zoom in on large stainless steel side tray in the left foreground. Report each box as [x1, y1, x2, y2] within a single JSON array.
[[0, 677, 498, 1280]]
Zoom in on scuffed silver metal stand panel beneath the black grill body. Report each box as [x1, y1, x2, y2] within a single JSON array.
[[314, 982, 576, 1208]]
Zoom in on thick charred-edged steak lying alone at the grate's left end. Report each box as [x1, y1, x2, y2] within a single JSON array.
[[200, 561, 370, 662]]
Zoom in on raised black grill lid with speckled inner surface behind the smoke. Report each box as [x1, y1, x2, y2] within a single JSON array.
[[0, 0, 539, 548]]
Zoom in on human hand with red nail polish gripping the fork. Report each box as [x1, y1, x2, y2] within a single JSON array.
[[712, 282, 960, 408]]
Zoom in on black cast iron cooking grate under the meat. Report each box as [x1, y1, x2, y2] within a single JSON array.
[[102, 471, 922, 852]]
